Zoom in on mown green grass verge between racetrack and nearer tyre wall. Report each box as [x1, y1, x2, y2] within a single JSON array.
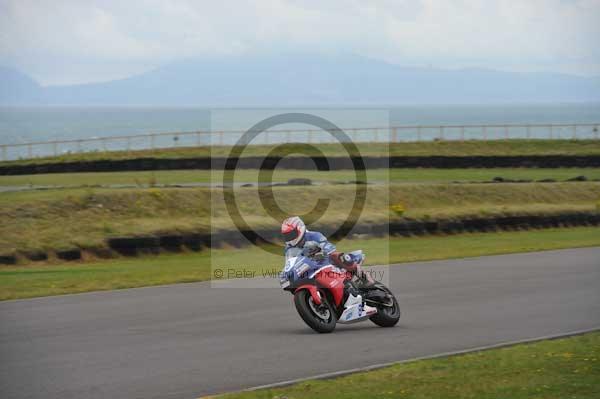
[[0, 227, 600, 300]]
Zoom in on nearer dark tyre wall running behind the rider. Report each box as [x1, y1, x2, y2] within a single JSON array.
[[0, 212, 600, 265]]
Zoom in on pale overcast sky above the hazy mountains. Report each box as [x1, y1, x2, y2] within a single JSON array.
[[0, 0, 600, 84]]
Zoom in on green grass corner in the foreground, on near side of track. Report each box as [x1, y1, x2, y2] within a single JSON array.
[[222, 332, 600, 399]]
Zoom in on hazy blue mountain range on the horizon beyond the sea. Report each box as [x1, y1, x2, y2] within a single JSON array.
[[0, 55, 600, 107]]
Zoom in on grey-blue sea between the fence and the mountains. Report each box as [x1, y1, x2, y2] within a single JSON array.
[[0, 103, 600, 158]]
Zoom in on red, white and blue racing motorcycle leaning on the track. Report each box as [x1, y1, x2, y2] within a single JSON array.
[[280, 250, 400, 333]]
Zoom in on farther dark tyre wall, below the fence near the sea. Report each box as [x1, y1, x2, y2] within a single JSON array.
[[0, 155, 600, 175]]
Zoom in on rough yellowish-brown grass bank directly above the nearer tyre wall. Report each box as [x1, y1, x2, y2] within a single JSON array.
[[0, 182, 600, 253]]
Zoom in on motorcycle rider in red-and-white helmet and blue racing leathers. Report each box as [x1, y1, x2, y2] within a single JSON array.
[[281, 216, 374, 286]]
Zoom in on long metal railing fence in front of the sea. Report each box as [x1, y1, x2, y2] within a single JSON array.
[[0, 123, 600, 161]]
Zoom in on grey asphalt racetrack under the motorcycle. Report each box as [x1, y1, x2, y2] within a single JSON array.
[[0, 248, 600, 399]]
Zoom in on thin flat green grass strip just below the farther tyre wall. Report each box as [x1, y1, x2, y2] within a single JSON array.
[[0, 168, 600, 187]]
